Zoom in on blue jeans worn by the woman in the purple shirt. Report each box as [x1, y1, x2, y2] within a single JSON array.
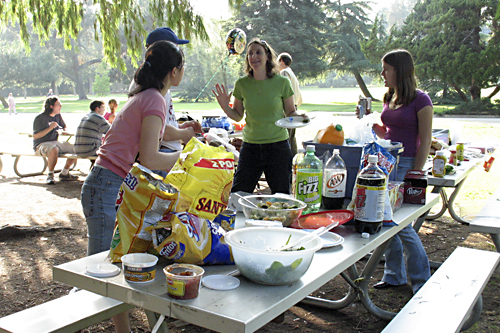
[[382, 157, 431, 293]]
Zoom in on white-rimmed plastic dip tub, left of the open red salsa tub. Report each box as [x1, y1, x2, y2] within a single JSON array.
[[121, 253, 158, 283]]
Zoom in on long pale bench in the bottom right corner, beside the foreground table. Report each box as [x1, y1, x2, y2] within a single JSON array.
[[382, 247, 500, 333]]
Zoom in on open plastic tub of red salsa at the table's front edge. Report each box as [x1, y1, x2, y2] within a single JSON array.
[[163, 264, 205, 299]]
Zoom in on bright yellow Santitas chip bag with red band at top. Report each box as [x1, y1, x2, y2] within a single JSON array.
[[164, 138, 234, 220]]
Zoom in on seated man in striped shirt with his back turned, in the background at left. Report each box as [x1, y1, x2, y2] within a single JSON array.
[[75, 100, 111, 157]]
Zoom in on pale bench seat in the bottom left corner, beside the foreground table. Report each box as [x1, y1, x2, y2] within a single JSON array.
[[0, 290, 133, 333]]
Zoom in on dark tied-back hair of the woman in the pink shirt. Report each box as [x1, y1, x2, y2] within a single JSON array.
[[128, 40, 184, 97]]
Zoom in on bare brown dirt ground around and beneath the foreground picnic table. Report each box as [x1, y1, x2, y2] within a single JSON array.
[[0, 156, 500, 333]]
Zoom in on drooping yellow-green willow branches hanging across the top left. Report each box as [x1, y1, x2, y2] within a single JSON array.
[[0, 0, 243, 71]]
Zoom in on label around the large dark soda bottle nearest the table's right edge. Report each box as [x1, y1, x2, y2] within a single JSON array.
[[354, 184, 386, 222]]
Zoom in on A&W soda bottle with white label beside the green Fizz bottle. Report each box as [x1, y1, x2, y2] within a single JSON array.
[[321, 149, 347, 209]]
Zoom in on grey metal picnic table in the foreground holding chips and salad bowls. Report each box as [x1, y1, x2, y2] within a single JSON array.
[[53, 193, 439, 332]]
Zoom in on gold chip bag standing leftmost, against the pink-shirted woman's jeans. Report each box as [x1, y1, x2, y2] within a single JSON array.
[[109, 163, 179, 262]]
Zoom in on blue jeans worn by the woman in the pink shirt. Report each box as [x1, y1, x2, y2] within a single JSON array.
[[81, 166, 123, 256]]
